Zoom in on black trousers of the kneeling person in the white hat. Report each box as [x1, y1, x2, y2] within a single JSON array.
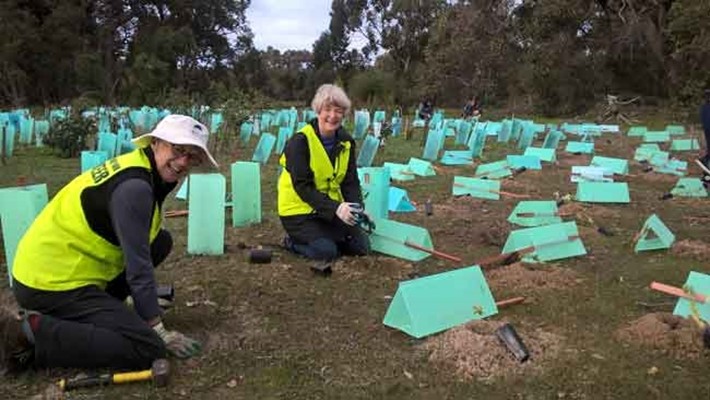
[[13, 230, 172, 370]]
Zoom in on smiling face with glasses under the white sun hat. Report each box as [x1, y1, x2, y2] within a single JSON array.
[[151, 139, 203, 183]]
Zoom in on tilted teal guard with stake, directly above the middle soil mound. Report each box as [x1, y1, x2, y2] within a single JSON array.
[[502, 221, 587, 263]]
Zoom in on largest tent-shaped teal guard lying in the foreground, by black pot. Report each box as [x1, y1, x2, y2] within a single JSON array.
[[382, 265, 498, 339]]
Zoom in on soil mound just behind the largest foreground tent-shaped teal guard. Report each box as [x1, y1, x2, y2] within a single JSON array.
[[486, 263, 582, 295]]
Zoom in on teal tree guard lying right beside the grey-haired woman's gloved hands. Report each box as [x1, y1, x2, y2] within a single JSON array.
[[370, 219, 434, 261]]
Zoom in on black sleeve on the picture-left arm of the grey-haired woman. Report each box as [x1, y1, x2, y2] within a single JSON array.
[[284, 133, 339, 221]]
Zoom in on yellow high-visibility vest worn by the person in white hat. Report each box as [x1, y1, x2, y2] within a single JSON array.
[[12, 149, 162, 291]]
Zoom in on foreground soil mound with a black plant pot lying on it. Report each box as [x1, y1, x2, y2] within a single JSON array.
[[422, 320, 562, 381]]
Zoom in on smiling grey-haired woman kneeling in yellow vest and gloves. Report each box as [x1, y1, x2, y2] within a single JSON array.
[[278, 84, 370, 261]]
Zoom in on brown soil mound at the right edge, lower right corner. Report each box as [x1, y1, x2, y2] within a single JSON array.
[[615, 313, 706, 358]]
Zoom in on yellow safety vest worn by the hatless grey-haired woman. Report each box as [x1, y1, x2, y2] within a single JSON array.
[[278, 124, 350, 217]]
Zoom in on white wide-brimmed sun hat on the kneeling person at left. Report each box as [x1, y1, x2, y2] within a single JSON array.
[[132, 114, 219, 168]]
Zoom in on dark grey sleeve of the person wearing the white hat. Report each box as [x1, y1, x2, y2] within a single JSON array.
[[109, 179, 161, 321]]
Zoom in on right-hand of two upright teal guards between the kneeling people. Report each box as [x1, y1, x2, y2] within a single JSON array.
[[232, 161, 261, 227]]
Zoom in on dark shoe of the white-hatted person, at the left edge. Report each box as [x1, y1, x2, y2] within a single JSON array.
[[0, 309, 34, 375]]
